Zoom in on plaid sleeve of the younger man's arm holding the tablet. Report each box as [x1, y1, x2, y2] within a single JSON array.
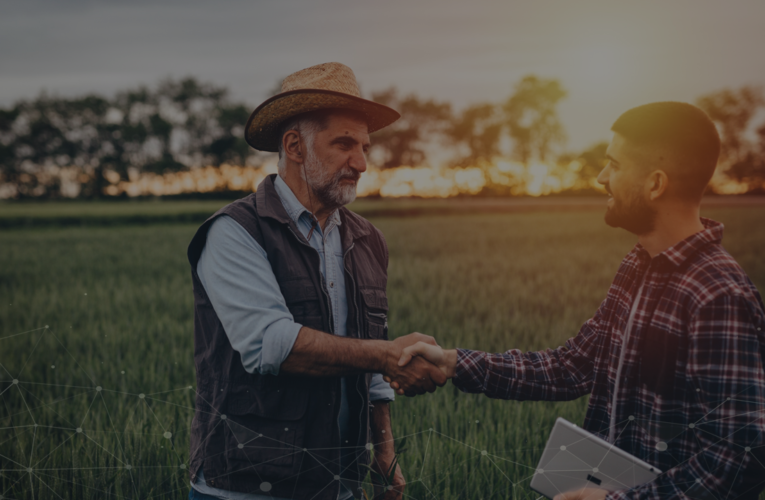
[[607, 295, 765, 500]]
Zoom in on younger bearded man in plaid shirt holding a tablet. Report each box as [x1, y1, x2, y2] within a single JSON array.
[[393, 102, 765, 500]]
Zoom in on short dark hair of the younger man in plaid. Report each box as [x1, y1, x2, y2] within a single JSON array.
[[611, 102, 720, 200]]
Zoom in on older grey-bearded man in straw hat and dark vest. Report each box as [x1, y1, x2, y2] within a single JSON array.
[[189, 63, 446, 500]]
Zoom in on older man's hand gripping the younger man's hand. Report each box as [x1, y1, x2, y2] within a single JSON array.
[[383, 332, 446, 396]]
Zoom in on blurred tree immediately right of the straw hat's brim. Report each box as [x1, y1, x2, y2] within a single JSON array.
[[372, 87, 451, 168]]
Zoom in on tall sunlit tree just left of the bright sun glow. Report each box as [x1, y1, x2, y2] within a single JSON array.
[[504, 75, 566, 164]]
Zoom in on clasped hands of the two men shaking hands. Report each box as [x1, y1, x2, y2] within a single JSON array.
[[383, 332, 457, 396]]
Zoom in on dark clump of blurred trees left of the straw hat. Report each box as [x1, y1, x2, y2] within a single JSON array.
[[0, 78, 253, 198]]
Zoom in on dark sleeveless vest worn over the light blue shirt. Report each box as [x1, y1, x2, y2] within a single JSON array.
[[188, 175, 388, 500]]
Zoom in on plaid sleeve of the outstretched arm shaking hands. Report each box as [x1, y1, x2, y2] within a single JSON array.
[[452, 302, 605, 401]]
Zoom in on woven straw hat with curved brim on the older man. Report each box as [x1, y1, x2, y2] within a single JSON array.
[[244, 63, 401, 152]]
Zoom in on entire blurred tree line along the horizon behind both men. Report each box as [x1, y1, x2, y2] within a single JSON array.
[[0, 75, 765, 199]]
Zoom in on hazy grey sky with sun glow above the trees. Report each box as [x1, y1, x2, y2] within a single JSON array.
[[0, 0, 765, 150]]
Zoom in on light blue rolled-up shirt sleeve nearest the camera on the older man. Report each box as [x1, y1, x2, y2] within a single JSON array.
[[197, 215, 302, 375]]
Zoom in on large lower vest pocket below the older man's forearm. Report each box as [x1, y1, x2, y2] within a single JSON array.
[[223, 388, 308, 477]]
